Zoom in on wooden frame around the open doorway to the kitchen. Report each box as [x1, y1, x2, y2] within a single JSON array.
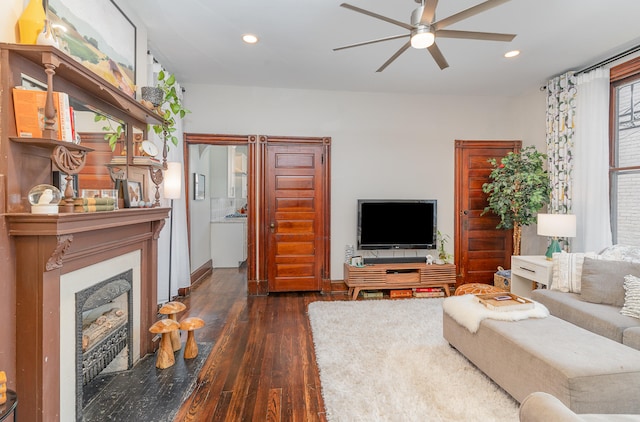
[[183, 133, 257, 285]]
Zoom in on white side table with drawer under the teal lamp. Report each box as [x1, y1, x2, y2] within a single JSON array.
[[511, 255, 553, 297]]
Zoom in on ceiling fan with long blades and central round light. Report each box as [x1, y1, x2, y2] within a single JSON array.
[[333, 0, 516, 72]]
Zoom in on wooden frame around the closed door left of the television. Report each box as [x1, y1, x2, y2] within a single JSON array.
[[258, 135, 331, 295]]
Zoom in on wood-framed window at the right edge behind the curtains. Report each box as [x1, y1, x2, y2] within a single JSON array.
[[609, 58, 640, 246]]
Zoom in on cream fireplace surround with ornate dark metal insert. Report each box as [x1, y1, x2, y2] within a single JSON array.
[[60, 251, 143, 421]]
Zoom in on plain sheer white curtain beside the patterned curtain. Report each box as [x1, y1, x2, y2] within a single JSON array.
[[572, 68, 612, 252]]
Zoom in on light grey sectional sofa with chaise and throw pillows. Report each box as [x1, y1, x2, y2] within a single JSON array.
[[443, 248, 640, 414]]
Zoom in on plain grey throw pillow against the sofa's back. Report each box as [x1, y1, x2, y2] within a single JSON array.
[[580, 258, 640, 308]]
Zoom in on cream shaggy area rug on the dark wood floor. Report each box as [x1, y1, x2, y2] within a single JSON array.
[[308, 298, 518, 422]]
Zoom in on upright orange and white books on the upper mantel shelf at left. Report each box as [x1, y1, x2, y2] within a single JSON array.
[[13, 87, 74, 142]]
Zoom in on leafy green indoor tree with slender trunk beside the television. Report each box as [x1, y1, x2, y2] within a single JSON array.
[[482, 146, 551, 255]]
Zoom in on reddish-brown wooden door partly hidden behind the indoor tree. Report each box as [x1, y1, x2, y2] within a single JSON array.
[[454, 140, 522, 286]]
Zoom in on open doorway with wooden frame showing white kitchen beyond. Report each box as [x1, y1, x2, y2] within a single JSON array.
[[184, 133, 257, 284]]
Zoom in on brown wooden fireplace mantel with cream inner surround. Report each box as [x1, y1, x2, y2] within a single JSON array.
[[5, 208, 169, 422]]
